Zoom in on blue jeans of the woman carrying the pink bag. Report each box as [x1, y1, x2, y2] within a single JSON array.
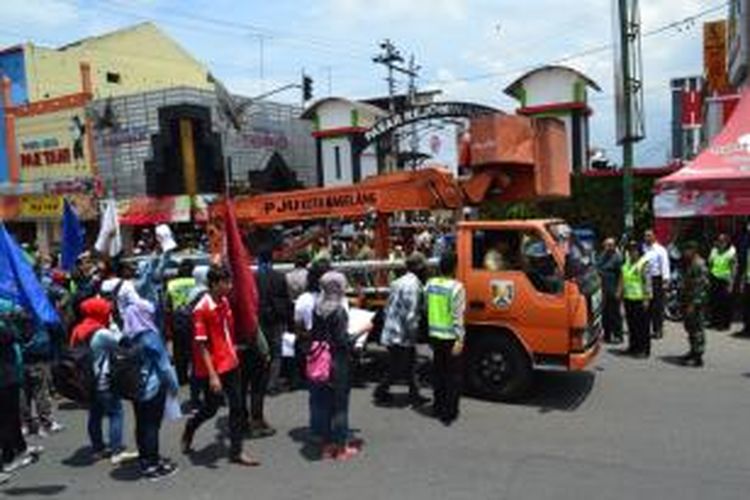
[[310, 384, 349, 446]]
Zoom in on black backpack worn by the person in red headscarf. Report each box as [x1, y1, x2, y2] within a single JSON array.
[[52, 344, 96, 404]]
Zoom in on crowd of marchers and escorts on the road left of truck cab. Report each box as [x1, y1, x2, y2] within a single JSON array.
[[0, 223, 465, 482]]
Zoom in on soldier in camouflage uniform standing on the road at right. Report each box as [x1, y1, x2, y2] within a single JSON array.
[[680, 242, 709, 367]]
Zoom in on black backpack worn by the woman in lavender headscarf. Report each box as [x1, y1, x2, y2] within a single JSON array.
[[109, 335, 148, 401]]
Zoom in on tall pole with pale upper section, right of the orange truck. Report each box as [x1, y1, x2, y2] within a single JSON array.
[[615, 0, 644, 237]]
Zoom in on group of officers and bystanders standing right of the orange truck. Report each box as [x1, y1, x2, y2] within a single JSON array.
[[596, 227, 750, 367]]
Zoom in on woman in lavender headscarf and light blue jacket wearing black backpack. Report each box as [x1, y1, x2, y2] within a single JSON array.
[[124, 297, 179, 480]]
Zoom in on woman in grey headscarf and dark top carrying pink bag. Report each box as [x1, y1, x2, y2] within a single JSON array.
[[310, 271, 360, 460]]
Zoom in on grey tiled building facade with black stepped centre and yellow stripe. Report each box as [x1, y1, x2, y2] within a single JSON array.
[[89, 87, 317, 198]]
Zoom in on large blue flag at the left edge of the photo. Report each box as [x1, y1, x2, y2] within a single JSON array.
[[0, 224, 60, 325]]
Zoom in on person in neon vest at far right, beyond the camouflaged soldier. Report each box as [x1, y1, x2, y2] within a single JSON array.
[[708, 233, 737, 330]]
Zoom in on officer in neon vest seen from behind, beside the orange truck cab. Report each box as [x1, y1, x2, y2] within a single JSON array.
[[425, 252, 466, 425]]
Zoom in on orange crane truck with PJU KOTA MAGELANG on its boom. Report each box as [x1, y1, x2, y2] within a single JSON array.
[[214, 114, 601, 400]]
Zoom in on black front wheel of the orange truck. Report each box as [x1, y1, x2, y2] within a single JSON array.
[[465, 334, 532, 401]]
